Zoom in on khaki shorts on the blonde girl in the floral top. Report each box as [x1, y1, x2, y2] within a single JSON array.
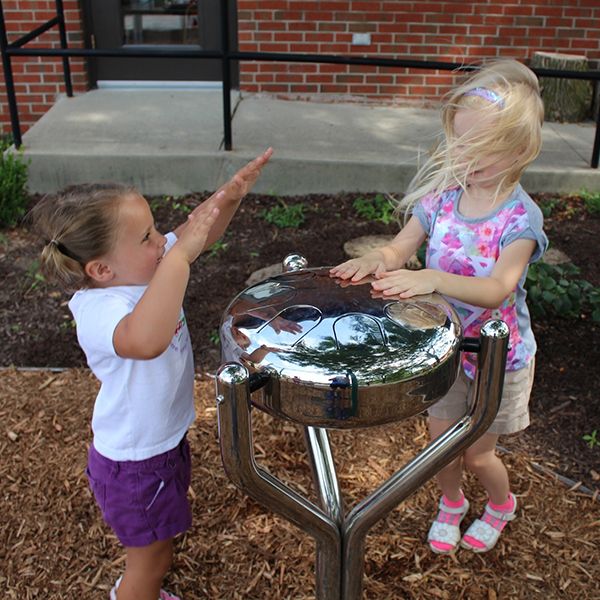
[[428, 359, 535, 435]]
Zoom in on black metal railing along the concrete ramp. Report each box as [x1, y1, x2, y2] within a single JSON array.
[[0, 0, 600, 169]]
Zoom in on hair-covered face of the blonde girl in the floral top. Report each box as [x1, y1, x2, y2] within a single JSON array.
[[453, 108, 516, 188]]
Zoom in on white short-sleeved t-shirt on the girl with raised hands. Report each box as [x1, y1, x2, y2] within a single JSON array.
[[69, 234, 195, 461]]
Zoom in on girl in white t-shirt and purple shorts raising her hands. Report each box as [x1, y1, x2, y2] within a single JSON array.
[[32, 148, 272, 600]]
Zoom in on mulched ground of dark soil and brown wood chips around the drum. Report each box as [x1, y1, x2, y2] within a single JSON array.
[[0, 189, 600, 600]]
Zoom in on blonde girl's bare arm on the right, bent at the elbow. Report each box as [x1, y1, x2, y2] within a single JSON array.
[[372, 239, 536, 308]]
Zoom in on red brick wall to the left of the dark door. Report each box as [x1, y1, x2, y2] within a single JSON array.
[[0, 0, 88, 134]]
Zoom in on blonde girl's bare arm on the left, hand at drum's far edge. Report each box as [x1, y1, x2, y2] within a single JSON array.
[[330, 217, 426, 281]]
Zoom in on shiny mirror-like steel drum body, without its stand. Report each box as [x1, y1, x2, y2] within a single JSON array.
[[221, 268, 462, 428]]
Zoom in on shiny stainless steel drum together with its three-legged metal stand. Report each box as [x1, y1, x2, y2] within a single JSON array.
[[216, 256, 508, 600]]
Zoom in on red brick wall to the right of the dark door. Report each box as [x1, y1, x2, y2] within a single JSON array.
[[237, 0, 600, 104]]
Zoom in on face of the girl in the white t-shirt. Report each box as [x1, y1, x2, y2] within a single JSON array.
[[106, 194, 167, 286]]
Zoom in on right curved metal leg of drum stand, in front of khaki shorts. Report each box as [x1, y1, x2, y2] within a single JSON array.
[[342, 321, 509, 600]]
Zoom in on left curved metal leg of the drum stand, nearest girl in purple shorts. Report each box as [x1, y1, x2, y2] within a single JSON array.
[[216, 363, 342, 600]]
